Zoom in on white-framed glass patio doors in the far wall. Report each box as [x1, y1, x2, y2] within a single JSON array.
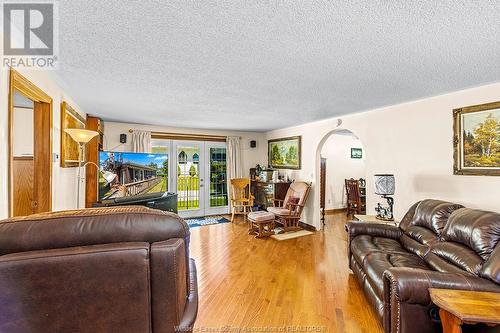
[[153, 140, 229, 217]]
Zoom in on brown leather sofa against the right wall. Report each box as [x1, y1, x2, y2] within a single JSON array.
[[347, 200, 500, 333]]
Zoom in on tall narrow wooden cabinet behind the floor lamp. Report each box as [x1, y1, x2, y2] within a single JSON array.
[[85, 116, 104, 208]]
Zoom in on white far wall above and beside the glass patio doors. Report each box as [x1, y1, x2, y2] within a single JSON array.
[[104, 121, 267, 176]]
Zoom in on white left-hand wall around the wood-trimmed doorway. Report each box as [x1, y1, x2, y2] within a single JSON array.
[[0, 68, 85, 219]]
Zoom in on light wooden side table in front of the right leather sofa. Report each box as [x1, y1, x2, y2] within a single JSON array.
[[429, 288, 500, 333]]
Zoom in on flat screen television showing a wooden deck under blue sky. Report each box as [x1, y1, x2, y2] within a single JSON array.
[[99, 151, 168, 201]]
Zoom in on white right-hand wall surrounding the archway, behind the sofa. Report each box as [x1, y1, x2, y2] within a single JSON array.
[[268, 83, 500, 228]]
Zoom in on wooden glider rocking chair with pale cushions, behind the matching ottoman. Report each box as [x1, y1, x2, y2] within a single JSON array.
[[267, 182, 311, 232]]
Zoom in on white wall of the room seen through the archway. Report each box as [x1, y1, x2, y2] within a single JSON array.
[[321, 134, 366, 209]]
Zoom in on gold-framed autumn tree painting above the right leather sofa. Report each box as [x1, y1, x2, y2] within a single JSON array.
[[453, 102, 500, 176]]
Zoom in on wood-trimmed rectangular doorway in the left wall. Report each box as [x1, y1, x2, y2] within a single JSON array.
[[8, 70, 52, 217]]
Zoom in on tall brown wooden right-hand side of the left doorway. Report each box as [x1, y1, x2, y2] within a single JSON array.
[[33, 102, 52, 213]]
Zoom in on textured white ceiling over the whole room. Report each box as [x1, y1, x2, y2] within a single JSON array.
[[52, 0, 500, 131]]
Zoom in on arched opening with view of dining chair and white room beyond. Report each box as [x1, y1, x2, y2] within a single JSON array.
[[317, 129, 366, 227]]
